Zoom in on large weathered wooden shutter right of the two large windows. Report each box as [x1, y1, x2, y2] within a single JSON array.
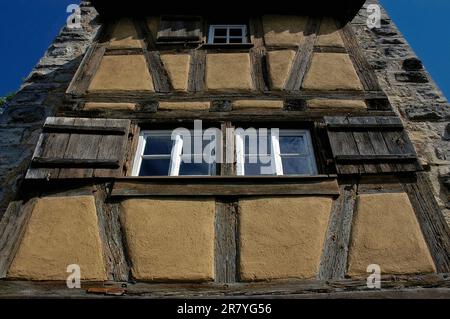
[[325, 117, 421, 174]]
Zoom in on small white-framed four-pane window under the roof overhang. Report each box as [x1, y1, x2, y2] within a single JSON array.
[[208, 24, 247, 44]]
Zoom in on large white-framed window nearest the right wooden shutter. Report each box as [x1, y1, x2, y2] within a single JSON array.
[[235, 129, 317, 176]]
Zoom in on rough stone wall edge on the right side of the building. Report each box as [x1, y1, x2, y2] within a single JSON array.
[[352, 0, 450, 223]]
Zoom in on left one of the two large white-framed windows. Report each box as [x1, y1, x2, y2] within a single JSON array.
[[132, 130, 216, 176]]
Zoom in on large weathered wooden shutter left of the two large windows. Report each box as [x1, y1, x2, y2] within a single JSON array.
[[26, 117, 131, 179]]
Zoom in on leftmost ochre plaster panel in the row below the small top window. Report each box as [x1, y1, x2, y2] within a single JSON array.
[[88, 55, 154, 92]]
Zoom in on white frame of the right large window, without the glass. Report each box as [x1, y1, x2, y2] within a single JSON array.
[[235, 129, 317, 176]]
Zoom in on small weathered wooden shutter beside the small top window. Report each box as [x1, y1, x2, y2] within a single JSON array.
[[157, 17, 202, 42]]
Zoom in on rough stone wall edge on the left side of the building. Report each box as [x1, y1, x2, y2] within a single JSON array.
[[0, 1, 100, 217]]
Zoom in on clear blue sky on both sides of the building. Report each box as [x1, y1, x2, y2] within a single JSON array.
[[0, 0, 450, 97]]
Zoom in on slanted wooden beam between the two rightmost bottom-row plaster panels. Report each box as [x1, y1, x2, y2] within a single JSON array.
[[318, 184, 356, 280]]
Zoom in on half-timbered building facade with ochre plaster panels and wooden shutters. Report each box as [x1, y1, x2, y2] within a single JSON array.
[[0, 1, 450, 297]]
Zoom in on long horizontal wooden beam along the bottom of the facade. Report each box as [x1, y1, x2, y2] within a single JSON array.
[[0, 274, 450, 299]]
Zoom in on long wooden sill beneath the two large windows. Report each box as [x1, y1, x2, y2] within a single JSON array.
[[110, 175, 340, 197]]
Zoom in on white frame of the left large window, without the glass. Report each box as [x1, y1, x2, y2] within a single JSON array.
[[132, 130, 217, 176]]
